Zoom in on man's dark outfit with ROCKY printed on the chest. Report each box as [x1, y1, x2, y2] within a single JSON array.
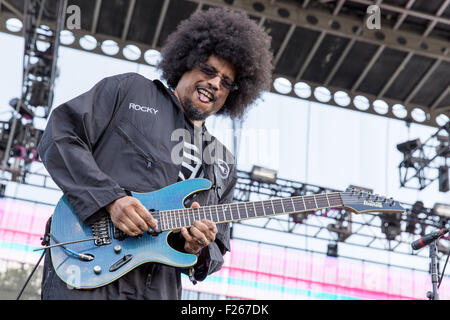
[[38, 73, 237, 299]]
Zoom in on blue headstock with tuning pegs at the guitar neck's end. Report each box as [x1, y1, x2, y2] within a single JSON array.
[[341, 188, 405, 214]]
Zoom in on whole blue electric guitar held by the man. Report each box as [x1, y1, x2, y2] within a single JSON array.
[[41, 179, 405, 289]]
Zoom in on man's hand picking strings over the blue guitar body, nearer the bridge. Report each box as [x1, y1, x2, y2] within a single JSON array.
[[106, 196, 158, 237]]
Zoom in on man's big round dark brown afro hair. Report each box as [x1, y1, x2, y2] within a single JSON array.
[[158, 8, 273, 119]]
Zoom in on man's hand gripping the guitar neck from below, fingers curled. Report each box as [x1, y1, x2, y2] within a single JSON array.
[[181, 202, 217, 254]]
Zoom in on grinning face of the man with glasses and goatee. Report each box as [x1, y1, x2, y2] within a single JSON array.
[[174, 55, 236, 121]]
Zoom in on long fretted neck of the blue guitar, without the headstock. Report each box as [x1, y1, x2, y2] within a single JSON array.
[[158, 192, 343, 231]]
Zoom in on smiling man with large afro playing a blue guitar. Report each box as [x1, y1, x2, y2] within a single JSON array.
[[38, 9, 273, 300]]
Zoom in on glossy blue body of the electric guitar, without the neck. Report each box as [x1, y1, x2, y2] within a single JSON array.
[[49, 179, 211, 289]]
